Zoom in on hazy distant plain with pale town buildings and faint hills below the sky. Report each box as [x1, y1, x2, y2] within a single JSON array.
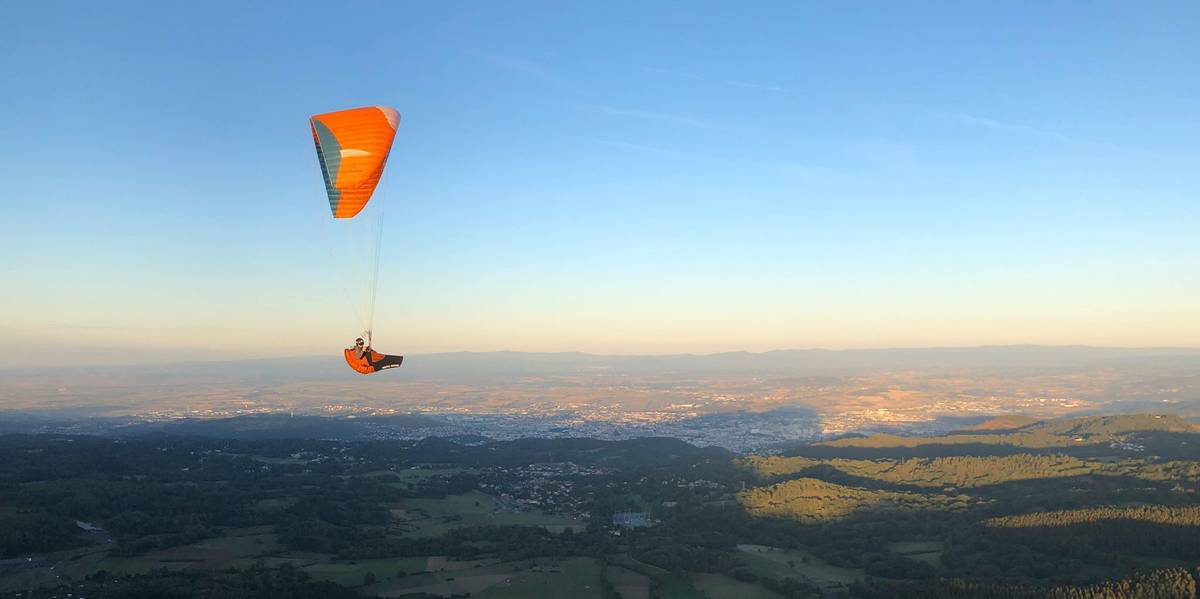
[[0, 346, 1200, 436]]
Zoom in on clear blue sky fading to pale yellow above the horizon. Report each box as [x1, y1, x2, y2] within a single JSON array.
[[0, 1, 1200, 367]]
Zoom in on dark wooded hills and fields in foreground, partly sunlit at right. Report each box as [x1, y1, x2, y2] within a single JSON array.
[[0, 417, 1200, 599]]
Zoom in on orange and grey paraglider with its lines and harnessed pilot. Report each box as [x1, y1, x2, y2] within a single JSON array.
[[308, 106, 404, 375]]
